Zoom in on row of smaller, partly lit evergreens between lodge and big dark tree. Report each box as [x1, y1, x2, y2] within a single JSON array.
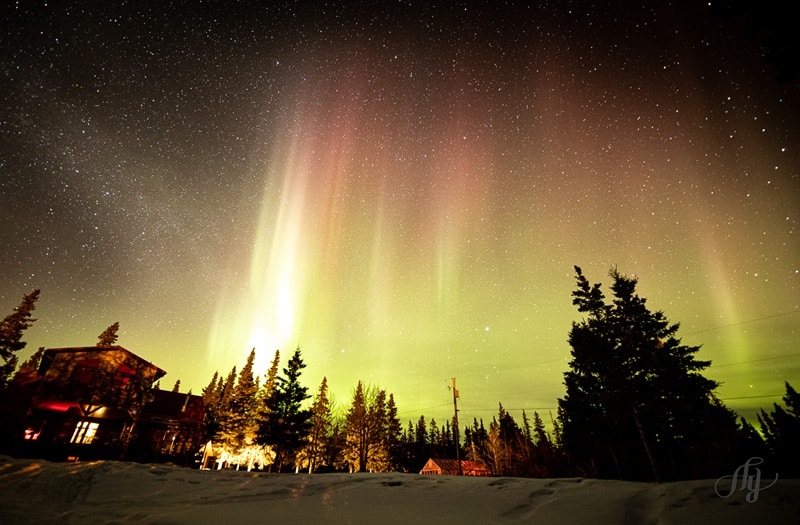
[[202, 348, 567, 476]]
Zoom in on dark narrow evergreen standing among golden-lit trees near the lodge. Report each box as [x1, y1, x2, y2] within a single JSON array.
[[258, 347, 311, 472]]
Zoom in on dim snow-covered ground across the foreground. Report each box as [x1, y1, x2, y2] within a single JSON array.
[[0, 456, 800, 525]]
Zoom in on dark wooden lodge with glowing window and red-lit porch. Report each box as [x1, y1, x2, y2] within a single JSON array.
[[0, 345, 204, 463]]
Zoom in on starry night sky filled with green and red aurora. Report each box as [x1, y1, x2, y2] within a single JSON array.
[[0, 0, 800, 422]]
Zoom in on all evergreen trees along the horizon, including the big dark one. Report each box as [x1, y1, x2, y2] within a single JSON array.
[[0, 266, 800, 481]]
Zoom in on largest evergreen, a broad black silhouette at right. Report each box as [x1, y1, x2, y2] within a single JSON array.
[[559, 267, 737, 480]]
